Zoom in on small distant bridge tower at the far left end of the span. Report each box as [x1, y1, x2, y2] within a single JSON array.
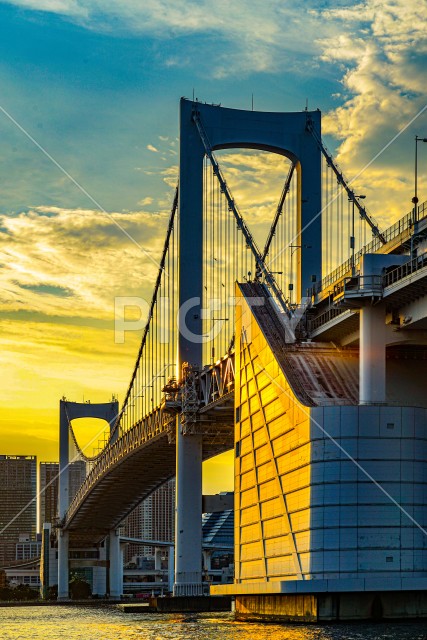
[[58, 400, 118, 600]]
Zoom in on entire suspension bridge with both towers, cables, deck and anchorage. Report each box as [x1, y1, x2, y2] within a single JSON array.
[[50, 99, 427, 619]]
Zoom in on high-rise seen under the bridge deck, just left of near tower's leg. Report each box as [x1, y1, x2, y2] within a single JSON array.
[[124, 479, 175, 561]]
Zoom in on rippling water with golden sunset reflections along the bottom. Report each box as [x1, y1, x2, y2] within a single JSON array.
[[0, 607, 427, 640]]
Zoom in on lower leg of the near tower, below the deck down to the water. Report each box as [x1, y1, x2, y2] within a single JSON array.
[[173, 425, 203, 596]]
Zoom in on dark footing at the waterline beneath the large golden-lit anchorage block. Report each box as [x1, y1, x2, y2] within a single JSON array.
[[235, 591, 427, 623]]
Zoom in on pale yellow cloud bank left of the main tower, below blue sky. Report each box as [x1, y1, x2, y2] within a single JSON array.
[[0, 207, 168, 320]]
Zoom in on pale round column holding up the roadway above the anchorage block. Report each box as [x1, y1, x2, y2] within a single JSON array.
[[359, 304, 386, 404]]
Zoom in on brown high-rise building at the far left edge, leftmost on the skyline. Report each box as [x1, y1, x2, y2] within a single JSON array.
[[0, 455, 37, 567]]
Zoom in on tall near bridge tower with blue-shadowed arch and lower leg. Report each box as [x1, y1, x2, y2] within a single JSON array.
[[174, 98, 322, 595]]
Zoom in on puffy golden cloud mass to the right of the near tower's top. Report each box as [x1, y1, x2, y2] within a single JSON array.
[[318, 0, 427, 226]]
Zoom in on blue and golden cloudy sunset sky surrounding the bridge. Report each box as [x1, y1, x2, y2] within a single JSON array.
[[0, 0, 427, 491]]
